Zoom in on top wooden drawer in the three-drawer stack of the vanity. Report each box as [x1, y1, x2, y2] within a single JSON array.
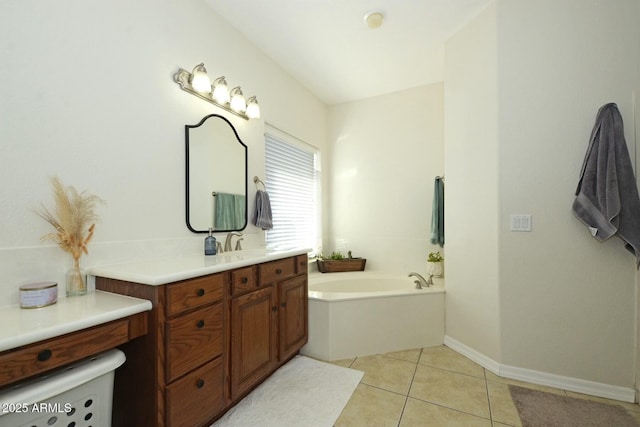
[[166, 274, 225, 316]]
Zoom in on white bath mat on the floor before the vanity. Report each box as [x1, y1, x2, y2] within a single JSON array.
[[211, 356, 364, 427]]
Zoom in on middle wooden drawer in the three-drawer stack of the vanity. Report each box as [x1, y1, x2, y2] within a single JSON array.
[[166, 304, 223, 383]]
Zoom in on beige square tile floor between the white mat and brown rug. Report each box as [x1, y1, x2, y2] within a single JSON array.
[[332, 346, 640, 427]]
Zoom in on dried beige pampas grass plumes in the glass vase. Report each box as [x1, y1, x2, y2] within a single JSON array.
[[35, 177, 105, 262]]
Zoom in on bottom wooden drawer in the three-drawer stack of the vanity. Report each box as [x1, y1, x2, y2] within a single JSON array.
[[166, 357, 224, 427]]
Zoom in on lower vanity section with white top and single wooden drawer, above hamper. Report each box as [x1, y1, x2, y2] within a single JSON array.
[[0, 291, 151, 387]]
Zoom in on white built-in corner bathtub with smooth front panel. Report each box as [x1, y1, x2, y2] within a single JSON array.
[[301, 272, 445, 360]]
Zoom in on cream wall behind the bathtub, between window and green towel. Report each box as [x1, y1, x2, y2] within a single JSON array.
[[323, 84, 444, 274]]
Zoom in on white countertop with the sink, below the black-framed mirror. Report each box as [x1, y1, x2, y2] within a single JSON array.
[[87, 248, 309, 286]]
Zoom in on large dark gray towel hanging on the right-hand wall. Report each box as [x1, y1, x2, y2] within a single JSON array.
[[573, 103, 640, 268]]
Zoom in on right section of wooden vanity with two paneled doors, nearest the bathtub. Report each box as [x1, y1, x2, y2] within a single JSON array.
[[229, 255, 308, 401]]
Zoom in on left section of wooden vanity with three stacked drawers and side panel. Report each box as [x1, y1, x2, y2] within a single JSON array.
[[96, 273, 228, 427]]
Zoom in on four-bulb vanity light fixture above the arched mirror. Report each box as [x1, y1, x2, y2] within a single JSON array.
[[173, 64, 260, 120]]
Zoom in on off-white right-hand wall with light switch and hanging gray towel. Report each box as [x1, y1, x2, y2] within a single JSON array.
[[445, 0, 640, 388]]
